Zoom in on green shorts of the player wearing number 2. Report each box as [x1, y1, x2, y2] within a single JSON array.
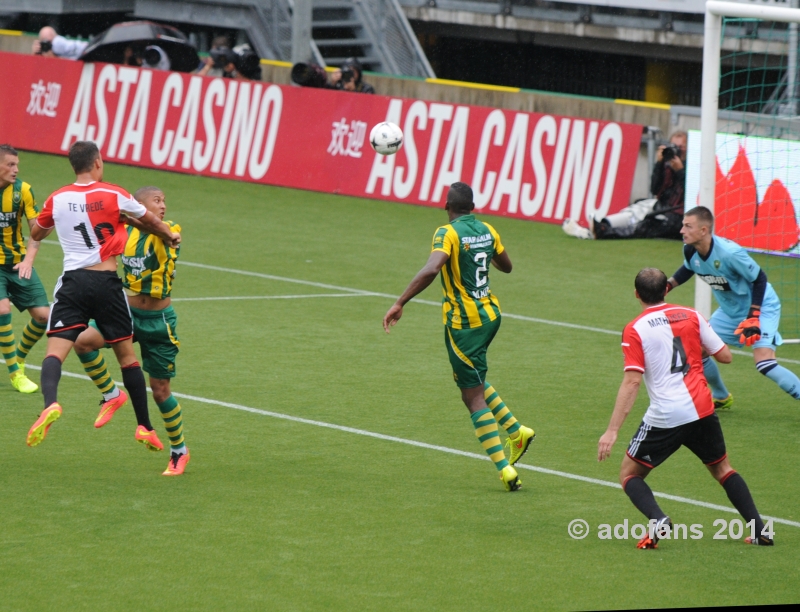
[[444, 317, 500, 389]]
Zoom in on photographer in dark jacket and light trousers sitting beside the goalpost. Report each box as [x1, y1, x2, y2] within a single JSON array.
[[561, 130, 687, 240]]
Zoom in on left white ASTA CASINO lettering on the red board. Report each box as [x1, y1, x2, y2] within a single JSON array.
[[61, 63, 283, 180]]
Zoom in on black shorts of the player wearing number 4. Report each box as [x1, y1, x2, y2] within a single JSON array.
[[627, 413, 727, 468]]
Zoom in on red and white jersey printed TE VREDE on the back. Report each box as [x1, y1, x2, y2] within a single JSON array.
[[36, 182, 147, 272]]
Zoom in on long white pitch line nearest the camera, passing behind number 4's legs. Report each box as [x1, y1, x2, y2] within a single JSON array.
[[25, 364, 800, 527]]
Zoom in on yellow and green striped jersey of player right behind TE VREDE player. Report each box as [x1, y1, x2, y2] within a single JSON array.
[[122, 221, 181, 299]]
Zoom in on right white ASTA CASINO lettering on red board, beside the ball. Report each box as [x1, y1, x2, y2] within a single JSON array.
[[365, 99, 623, 220]]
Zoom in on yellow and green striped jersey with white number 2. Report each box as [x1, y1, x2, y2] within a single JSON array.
[[432, 215, 505, 329]]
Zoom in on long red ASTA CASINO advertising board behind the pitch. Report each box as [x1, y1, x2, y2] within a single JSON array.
[[0, 53, 641, 223]]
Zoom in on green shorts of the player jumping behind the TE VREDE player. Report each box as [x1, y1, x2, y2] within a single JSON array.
[[89, 306, 181, 378]]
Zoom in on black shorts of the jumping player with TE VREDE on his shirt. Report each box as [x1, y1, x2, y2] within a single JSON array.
[[47, 270, 133, 344]]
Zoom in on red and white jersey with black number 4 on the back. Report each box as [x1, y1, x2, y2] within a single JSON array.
[[622, 304, 725, 428]]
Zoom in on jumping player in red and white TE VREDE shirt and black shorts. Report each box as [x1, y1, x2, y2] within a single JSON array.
[[27, 141, 181, 450]]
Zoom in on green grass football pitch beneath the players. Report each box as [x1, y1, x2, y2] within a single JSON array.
[[0, 153, 800, 610]]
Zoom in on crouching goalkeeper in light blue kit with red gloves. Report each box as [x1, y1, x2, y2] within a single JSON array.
[[669, 206, 800, 408]]
